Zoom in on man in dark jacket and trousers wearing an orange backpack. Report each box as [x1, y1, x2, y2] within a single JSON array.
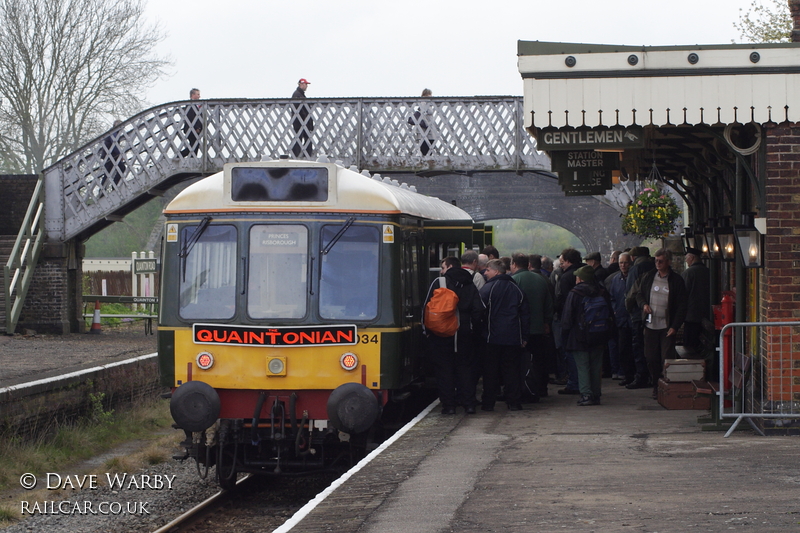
[[422, 257, 484, 415]]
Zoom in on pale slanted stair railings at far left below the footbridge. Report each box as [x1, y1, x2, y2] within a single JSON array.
[[3, 174, 45, 335]]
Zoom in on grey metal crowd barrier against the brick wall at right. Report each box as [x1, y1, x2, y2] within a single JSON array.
[[717, 322, 800, 437]]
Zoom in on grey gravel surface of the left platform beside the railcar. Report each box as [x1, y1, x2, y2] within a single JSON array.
[[0, 322, 157, 387]]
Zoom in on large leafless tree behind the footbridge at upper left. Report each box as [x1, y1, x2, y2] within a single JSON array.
[[0, 0, 168, 173]]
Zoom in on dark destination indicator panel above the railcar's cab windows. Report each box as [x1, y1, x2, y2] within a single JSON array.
[[231, 167, 328, 202]]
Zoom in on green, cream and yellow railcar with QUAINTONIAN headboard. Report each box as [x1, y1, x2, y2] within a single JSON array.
[[159, 160, 473, 485]]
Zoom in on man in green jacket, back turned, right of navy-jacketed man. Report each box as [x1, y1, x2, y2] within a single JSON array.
[[511, 253, 553, 401]]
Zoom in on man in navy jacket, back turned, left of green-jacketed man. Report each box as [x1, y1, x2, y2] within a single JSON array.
[[480, 259, 530, 411]]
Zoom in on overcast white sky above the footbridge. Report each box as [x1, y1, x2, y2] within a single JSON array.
[[146, 0, 768, 104]]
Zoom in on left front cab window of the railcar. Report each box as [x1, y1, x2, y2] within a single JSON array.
[[180, 225, 237, 320]]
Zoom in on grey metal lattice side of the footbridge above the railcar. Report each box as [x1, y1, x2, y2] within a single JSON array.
[[44, 96, 550, 241]]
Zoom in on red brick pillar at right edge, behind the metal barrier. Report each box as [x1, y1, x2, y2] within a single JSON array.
[[761, 123, 800, 401]]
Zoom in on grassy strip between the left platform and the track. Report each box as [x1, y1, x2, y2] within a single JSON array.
[[0, 399, 175, 494]]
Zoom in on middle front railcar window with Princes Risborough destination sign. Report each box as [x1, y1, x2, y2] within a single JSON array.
[[247, 224, 308, 318]]
